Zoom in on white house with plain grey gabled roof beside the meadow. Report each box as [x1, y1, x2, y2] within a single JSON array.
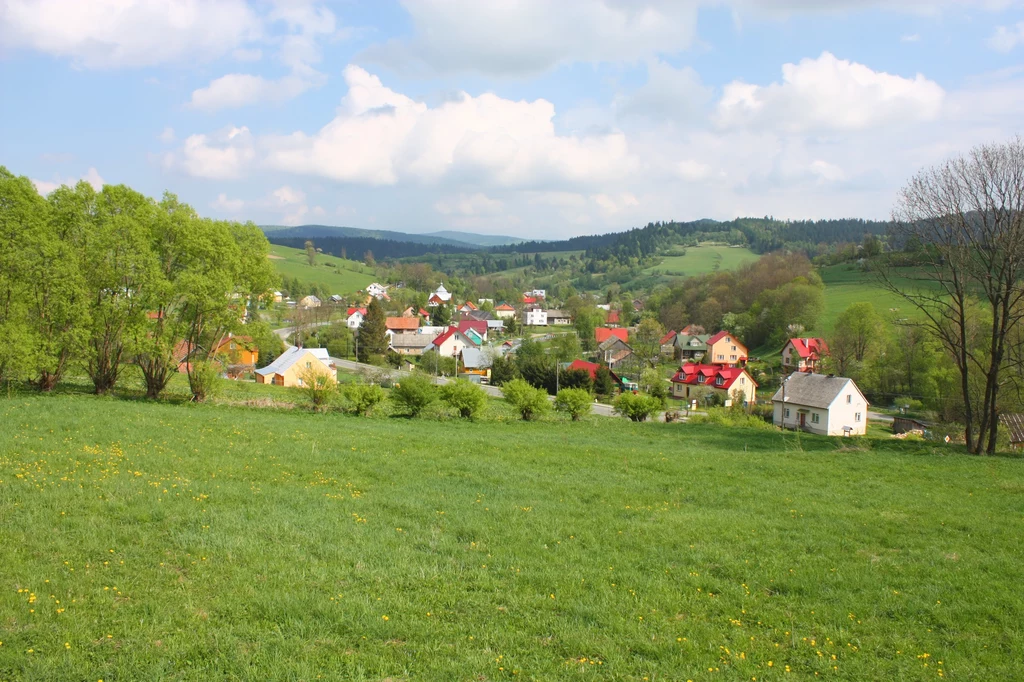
[[771, 372, 868, 436]]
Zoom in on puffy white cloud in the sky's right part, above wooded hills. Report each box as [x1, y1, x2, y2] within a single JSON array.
[[717, 52, 945, 132]]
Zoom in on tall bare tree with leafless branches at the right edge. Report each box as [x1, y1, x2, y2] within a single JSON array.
[[880, 137, 1024, 454]]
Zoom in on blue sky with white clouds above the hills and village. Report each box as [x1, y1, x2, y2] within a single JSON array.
[[0, 0, 1024, 239]]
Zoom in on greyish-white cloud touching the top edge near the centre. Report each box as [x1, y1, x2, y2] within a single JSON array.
[[366, 0, 699, 74]]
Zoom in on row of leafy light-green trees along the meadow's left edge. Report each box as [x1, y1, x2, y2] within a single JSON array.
[[0, 167, 278, 400]]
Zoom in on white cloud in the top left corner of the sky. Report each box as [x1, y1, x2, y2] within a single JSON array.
[[0, 0, 260, 69]]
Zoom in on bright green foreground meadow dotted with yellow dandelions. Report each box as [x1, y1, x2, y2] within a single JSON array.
[[0, 395, 1024, 681]]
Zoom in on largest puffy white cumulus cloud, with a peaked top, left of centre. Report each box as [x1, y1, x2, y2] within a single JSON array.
[[180, 66, 636, 187]]
